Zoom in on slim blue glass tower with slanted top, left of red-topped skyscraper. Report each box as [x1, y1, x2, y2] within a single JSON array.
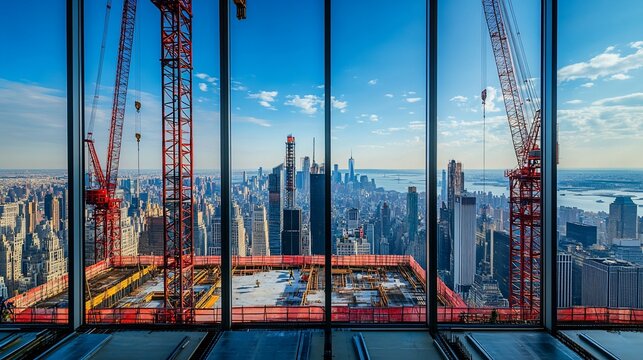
[[268, 164, 284, 255]]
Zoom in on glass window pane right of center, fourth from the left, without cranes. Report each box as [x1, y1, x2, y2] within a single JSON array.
[[328, 1, 427, 323]]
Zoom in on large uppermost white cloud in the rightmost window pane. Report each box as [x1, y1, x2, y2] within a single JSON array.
[[558, 41, 643, 82]]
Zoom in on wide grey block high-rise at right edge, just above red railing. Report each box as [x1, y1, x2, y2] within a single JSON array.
[[582, 259, 643, 308]]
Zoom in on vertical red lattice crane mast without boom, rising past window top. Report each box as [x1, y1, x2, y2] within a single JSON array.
[[152, 0, 194, 323]]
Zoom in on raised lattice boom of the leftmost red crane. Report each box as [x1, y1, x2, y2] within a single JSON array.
[[105, 0, 136, 197]]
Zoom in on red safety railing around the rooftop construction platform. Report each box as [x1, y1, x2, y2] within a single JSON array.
[[0, 255, 643, 325]]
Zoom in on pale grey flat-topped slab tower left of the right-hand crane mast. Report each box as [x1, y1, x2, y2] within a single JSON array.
[[453, 196, 476, 293]]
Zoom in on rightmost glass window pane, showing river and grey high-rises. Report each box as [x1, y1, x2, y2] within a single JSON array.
[[556, 1, 643, 324]]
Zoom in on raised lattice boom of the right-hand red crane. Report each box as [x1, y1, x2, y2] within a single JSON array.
[[482, 0, 529, 166]]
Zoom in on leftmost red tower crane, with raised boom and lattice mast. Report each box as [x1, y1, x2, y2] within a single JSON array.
[[85, 0, 136, 262]]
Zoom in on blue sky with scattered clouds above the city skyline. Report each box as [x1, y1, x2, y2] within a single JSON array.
[[0, 0, 643, 169]]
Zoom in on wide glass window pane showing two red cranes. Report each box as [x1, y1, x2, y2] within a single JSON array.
[[85, 0, 221, 324]]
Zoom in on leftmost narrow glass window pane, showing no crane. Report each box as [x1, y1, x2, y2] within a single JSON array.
[[0, 1, 70, 324]]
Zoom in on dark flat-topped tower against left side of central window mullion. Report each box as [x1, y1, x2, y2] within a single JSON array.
[[310, 174, 326, 255]]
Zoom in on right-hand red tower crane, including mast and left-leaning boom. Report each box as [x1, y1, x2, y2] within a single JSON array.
[[482, 0, 541, 319]]
